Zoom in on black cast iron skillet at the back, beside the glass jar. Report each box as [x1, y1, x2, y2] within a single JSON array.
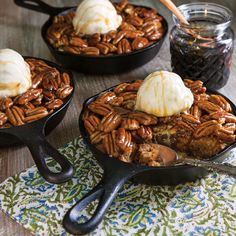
[[14, 0, 168, 74]]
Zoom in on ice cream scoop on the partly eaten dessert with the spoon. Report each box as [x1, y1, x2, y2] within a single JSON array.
[[135, 71, 194, 117]]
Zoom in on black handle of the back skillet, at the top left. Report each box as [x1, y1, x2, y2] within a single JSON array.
[[14, 0, 68, 16]]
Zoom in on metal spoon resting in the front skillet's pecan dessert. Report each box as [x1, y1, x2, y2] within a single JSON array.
[[156, 144, 236, 177]]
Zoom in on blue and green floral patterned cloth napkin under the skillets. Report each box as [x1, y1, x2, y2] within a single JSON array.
[[0, 138, 236, 236]]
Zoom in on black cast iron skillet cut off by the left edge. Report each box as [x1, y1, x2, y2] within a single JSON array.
[[0, 57, 75, 184]]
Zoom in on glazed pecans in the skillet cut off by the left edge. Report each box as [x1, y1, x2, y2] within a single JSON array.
[[0, 59, 73, 128]]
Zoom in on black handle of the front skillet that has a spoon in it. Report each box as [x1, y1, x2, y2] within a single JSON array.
[[63, 166, 141, 235]]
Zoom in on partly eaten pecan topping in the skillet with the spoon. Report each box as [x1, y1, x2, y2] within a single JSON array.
[[83, 80, 236, 166]]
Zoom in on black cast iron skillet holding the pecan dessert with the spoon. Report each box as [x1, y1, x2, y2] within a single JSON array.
[[63, 87, 236, 235]]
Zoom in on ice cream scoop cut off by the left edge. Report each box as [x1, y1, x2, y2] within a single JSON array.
[[0, 49, 32, 97]]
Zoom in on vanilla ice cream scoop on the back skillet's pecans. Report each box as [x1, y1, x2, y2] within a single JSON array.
[[73, 0, 122, 35]]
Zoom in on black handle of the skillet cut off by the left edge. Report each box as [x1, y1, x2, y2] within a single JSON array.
[[13, 124, 73, 184]]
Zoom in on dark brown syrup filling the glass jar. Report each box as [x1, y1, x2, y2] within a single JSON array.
[[170, 19, 234, 89]]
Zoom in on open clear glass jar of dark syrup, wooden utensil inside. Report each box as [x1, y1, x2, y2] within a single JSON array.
[[170, 2, 234, 89]]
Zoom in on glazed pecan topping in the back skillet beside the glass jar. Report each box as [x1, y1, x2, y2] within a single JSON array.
[[47, 0, 163, 56]]
